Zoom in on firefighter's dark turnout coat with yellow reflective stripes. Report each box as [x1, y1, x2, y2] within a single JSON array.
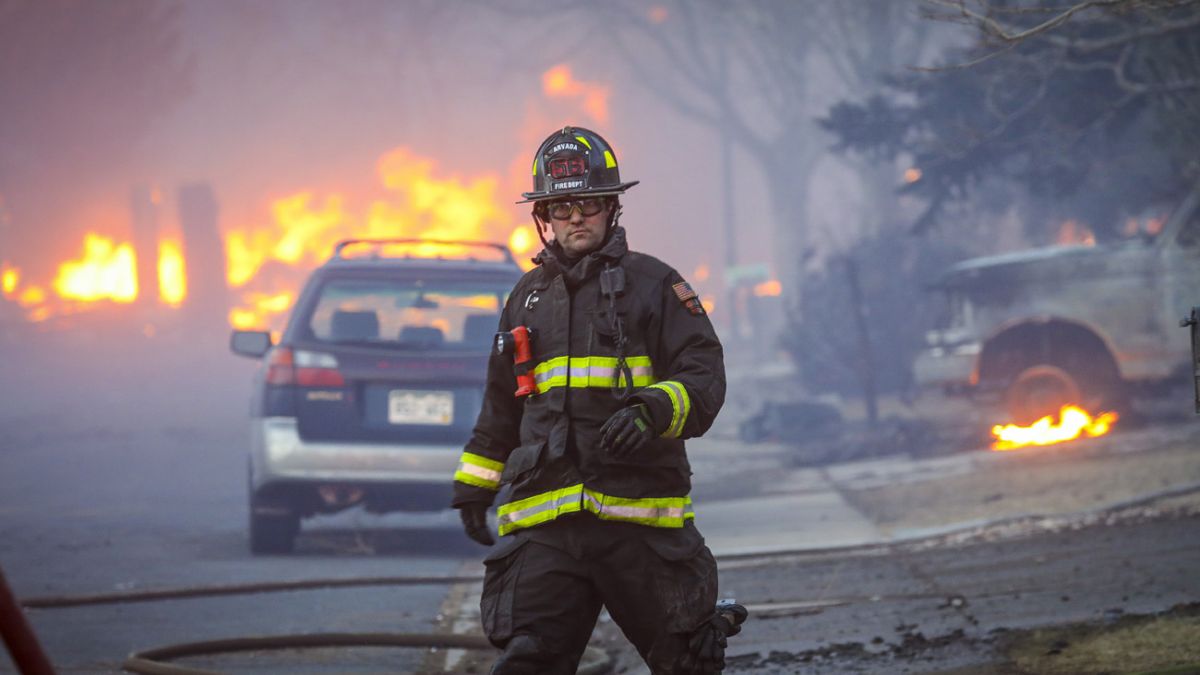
[[454, 227, 725, 534]]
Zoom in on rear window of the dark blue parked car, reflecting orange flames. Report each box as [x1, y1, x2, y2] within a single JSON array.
[[307, 279, 511, 350]]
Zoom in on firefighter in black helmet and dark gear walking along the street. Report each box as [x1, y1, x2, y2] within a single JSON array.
[[454, 127, 729, 674]]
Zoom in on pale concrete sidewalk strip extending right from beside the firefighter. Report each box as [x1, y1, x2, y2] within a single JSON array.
[[689, 422, 1200, 556]]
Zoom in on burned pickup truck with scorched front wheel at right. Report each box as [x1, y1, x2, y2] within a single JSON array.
[[914, 190, 1200, 424]]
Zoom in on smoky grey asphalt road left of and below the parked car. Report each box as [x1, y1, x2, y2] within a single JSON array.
[[0, 336, 481, 673]]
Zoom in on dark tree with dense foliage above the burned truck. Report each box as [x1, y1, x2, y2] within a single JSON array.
[[827, 0, 1200, 240]]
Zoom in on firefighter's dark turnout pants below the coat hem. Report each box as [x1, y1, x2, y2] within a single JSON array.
[[480, 514, 716, 675]]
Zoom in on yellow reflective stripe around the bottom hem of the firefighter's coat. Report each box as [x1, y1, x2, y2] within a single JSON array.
[[497, 484, 696, 536]]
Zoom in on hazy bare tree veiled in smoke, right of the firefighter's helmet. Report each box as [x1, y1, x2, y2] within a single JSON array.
[[552, 0, 926, 288]]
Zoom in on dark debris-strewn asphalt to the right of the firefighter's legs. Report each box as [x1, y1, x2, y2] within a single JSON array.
[[594, 509, 1200, 675]]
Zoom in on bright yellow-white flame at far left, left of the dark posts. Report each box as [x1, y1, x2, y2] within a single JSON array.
[[54, 232, 138, 303]]
